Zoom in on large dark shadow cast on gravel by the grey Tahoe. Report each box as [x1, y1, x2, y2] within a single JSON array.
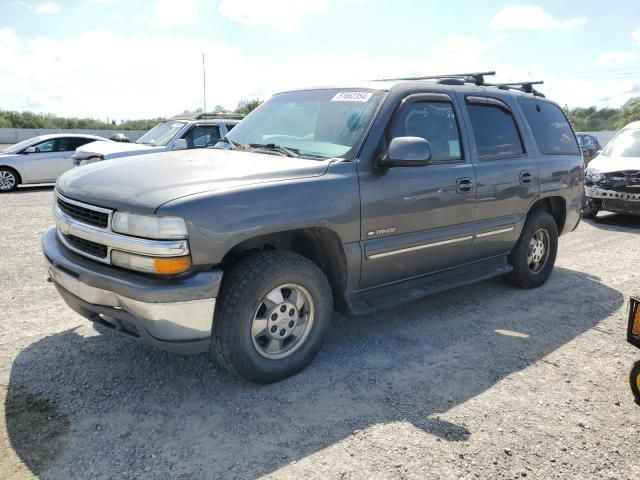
[[5, 268, 624, 478]]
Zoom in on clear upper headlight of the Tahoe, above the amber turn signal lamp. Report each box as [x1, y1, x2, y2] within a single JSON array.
[[111, 212, 187, 240]]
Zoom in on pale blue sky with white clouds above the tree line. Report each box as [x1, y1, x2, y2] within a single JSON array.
[[0, 0, 640, 121]]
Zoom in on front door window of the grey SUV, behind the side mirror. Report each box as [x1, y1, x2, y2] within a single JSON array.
[[389, 101, 463, 163]]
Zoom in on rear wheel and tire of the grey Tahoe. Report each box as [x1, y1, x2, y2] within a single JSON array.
[[505, 210, 558, 288]]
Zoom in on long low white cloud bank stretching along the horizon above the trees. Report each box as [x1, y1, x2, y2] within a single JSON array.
[[0, 28, 637, 120]]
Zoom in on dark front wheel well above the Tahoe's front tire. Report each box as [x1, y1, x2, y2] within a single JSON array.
[[221, 227, 347, 299]]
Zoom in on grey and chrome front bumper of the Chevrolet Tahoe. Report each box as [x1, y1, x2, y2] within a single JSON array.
[[42, 228, 222, 353]]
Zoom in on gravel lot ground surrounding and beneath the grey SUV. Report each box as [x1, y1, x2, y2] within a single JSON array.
[[0, 187, 640, 479]]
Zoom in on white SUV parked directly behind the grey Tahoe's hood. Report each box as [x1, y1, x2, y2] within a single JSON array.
[[74, 113, 243, 167]]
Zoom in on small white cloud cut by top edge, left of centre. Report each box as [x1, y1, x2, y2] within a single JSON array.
[[218, 0, 330, 31]]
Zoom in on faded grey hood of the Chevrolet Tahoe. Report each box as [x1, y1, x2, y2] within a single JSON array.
[[56, 149, 329, 213]]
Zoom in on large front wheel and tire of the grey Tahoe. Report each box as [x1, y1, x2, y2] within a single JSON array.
[[212, 250, 333, 383]]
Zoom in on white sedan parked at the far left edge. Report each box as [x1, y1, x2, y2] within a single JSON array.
[[0, 133, 107, 193]]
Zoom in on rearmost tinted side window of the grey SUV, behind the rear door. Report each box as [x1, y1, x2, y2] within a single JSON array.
[[518, 98, 580, 155]]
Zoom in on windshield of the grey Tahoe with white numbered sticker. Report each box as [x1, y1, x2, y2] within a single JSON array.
[[221, 90, 384, 159]]
